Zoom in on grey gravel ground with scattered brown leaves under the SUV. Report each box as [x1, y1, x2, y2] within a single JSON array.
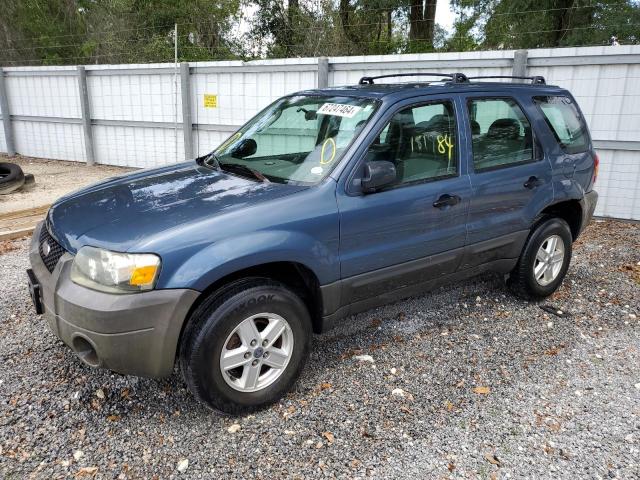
[[0, 221, 640, 478]]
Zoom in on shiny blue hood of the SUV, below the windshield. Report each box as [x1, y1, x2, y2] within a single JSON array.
[[47, 162, 307, 253]]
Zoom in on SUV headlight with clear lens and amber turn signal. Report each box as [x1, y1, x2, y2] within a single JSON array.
[[71, 247, 160, 293]]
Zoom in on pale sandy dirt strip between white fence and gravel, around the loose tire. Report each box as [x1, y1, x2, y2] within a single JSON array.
[[0, 154, 134, 215]]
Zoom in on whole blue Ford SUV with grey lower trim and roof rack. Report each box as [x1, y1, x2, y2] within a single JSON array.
[[28, 73, 598, 413]]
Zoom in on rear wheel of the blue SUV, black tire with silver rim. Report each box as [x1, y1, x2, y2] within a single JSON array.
[[508, 217, 573, 300]]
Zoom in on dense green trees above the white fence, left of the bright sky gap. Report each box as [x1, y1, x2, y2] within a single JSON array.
[[0, 0, 240, 64]]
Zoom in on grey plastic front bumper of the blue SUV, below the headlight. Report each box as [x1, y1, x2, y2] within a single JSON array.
[[29, 223, 199, 377]]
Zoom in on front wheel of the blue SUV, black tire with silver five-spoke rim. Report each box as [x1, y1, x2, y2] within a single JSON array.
[[179, 278, 312, 415]]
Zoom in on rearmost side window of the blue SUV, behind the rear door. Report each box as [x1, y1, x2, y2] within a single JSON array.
[[533, 95, 589, 153]]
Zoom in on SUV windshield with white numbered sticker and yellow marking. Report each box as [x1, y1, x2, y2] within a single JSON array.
[[206, 95, 377, 185]]
